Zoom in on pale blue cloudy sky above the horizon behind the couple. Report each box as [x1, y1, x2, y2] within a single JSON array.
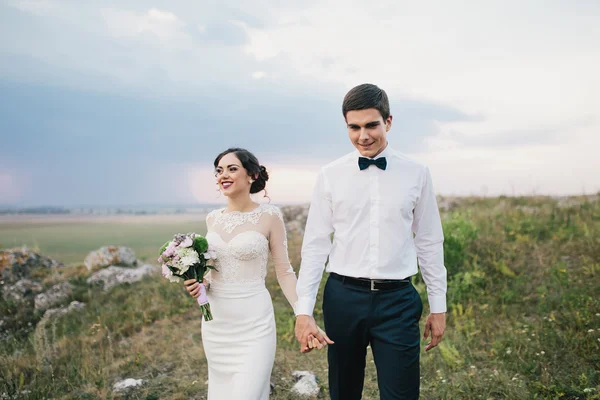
[[0, 0, 600, 206]]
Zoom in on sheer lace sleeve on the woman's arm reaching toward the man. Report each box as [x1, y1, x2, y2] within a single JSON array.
[[269, 208, 298, 311]]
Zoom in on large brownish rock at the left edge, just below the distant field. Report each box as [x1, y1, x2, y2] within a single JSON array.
[[0, 248, 62, 285]]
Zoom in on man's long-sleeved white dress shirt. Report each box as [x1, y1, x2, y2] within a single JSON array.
[[296, 145, 447, 315]]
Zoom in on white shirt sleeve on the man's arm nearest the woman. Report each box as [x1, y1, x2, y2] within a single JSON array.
[[296, 170, 333, 316]]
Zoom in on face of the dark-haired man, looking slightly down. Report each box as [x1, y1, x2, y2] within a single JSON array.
[[346, 108, 392, 158]]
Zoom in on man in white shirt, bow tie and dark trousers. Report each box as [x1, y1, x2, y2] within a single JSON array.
[[296, 84, 446, 400]]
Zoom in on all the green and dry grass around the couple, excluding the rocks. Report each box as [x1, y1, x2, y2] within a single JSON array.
[[0, 196, 600, 400]]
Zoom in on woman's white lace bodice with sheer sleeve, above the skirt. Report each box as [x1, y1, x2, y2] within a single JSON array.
[[206, 204, 297, 306]]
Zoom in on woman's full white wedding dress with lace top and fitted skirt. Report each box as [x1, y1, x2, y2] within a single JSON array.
[[202, 204, 297, 400]]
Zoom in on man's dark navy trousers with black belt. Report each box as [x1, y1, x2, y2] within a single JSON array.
[[323, 277, 423, 400]]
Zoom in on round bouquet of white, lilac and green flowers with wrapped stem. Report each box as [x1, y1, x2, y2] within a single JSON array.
[[158, 233, 216, 321]]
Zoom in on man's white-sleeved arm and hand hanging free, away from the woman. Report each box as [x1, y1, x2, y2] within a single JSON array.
[[413, 168, 447, 350]]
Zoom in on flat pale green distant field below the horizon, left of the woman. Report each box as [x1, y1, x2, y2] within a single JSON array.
[[0, 214, 206, 264]]
